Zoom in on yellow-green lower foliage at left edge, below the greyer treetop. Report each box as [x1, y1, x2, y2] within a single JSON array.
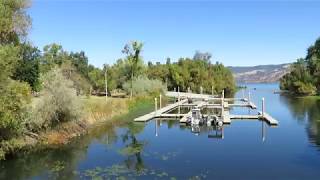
[[0, 45, 30, 141]]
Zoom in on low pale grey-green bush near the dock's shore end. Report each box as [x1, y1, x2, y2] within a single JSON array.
[[123, 76, 166, 96]]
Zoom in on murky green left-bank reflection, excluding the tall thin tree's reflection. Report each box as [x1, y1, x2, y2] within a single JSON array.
[[0, 116, 127, 179]]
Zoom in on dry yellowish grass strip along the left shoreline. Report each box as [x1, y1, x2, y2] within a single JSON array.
[[0, 96, 152, 160]]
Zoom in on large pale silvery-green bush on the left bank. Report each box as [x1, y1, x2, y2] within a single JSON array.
[[29, 69, 82, 130]]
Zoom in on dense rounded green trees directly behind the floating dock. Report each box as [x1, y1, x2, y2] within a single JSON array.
[[147, 55, 235, 94]]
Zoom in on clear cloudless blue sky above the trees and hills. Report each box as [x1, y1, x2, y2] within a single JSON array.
[[28, 0, 320, 67]]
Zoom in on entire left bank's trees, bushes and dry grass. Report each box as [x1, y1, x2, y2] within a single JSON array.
[[0, 0, 235, 159]]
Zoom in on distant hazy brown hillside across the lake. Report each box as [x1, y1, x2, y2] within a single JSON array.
[[228, 64, 290, 83]]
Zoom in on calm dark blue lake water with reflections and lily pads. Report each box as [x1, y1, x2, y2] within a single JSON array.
[[0, 84, 320, 180]]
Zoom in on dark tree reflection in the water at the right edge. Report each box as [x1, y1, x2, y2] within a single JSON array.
[[280, 96, 320, 148]]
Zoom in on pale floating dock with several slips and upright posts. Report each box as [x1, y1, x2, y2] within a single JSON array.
[[134, 91, 278, 126]]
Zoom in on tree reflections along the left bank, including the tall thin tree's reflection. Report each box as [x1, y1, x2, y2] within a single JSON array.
[[0, 111, 146, 179]]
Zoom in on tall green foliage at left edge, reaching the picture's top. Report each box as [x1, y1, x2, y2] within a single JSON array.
[[0, 0, 31, 141]]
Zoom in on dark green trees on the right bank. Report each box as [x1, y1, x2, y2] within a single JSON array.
[[280, 38, 320, 95]]
